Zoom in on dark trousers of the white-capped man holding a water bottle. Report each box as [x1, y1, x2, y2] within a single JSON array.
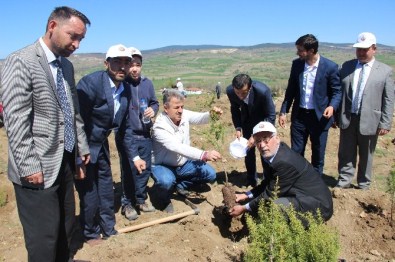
[[120, 137, 152, 206]]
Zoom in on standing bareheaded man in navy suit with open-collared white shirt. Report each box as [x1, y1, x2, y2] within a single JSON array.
[[278, 34, 341, 175]]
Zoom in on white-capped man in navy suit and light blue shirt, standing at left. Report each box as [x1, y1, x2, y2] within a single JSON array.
[[75, 45, 132, 244]]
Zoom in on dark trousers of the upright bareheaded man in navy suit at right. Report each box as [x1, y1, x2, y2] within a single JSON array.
[[291, 110, 328, 175]]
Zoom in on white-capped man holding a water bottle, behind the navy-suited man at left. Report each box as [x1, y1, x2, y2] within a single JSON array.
[[116, 47, 159, 220]]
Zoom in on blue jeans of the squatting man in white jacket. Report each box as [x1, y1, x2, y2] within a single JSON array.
[[152, 160, 217, 203]]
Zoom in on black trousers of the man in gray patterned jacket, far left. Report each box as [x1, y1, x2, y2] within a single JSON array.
[[14, 151, 75, 262]]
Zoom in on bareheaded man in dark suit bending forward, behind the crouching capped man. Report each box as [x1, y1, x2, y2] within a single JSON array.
[[226, 74, 276, 186]]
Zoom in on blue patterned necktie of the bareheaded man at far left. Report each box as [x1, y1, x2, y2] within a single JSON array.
[[53, 59, 75, 152]]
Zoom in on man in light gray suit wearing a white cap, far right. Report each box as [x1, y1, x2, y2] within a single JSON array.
[[337, 32, 394, 189]]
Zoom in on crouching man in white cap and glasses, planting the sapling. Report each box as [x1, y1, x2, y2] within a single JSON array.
[[229, 122, 333, 221]]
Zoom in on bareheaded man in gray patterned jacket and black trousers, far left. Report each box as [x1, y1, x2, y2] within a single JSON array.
[[1, 6, 90, 261]]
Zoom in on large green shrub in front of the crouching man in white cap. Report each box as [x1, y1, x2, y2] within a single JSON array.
[[243, 195, 340, 262]]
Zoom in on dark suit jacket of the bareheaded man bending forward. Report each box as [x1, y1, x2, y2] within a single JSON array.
[[226, 81, 276, 138]]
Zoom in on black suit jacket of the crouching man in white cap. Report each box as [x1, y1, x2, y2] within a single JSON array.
[[250, 142, 333, 220]]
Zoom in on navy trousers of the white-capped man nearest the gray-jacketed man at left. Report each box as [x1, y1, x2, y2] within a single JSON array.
[[75, 148, 117, 240]]
